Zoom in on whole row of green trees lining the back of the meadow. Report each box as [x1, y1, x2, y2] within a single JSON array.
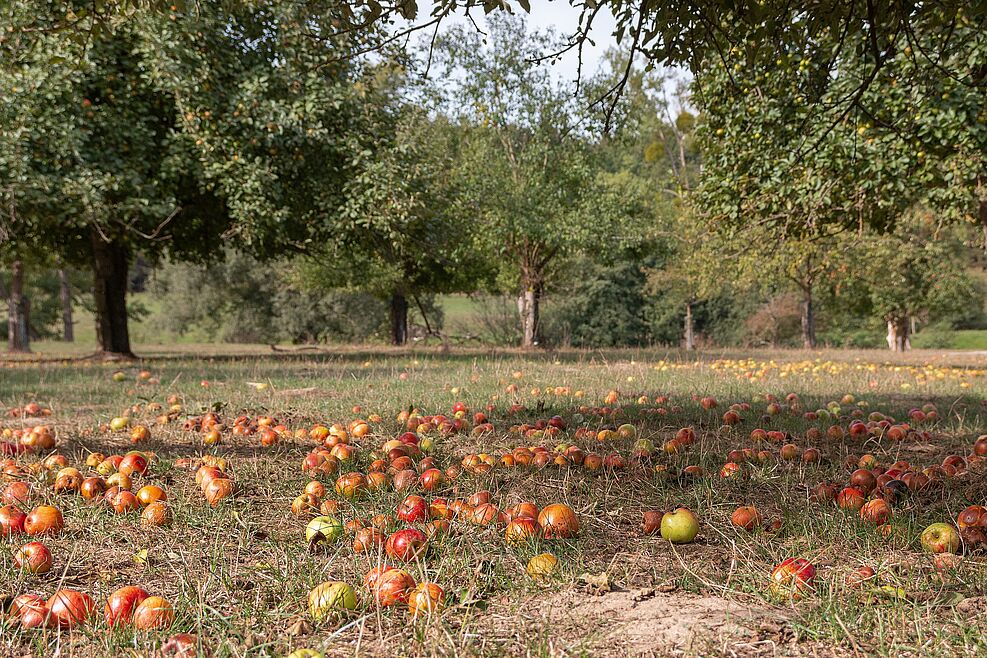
[[0, 2, 987, 354]]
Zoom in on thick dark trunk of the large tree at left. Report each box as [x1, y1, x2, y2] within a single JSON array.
[[92, 232, 134, 358]]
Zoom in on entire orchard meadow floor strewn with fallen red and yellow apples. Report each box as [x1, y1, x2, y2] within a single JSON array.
[[0, 348, 987, 658]]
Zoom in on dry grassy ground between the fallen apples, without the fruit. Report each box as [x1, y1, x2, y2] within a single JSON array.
[[0, 344, 987, 657]]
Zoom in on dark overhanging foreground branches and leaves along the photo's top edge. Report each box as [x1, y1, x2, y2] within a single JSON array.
[[7, 0, 987, 142]]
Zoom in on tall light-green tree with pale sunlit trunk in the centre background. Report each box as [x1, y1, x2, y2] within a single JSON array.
[[435, 17, 635, 347]]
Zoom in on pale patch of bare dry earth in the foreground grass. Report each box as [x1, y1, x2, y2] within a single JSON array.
[[529, 589, 776, 656]]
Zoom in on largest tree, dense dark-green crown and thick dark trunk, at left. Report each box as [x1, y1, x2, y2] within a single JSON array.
[[0, 2, 386, 355]]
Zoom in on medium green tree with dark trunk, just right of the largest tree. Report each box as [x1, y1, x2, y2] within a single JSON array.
[[296, 103, 489, 345]]
